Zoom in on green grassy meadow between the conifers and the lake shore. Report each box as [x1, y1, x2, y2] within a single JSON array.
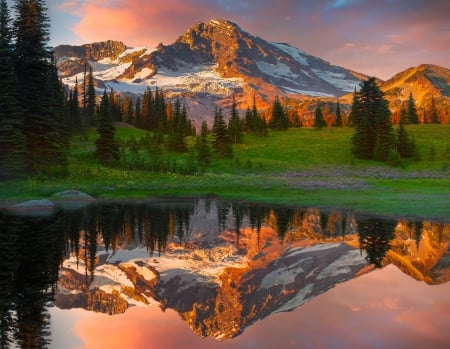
[[0, 125, 450, 220]]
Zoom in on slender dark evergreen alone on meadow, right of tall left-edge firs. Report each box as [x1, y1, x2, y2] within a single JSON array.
[[95, 91, 119, 163]]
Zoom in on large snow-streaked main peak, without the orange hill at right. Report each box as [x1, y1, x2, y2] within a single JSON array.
[[54, 20, 364, 113]]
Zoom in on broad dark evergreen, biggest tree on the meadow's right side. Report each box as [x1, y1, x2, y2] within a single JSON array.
[[351, 78, 395, 161]]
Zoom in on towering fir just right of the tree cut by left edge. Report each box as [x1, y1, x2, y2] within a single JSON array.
[[14, 0, 67, 174]]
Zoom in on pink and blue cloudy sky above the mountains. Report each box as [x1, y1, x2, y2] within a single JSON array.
[[14, 0, 450, 79]]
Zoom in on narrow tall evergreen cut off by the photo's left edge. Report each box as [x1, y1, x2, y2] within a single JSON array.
[[0, 0, 25, 179]]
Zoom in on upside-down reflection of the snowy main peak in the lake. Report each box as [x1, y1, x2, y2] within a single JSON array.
[[56, 223, 367, 341]]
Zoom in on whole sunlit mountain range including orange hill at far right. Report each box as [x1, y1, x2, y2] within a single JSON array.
[[54, 19, 450, 124]]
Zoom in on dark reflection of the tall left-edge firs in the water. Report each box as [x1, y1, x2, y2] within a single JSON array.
[[0, 212, 66, 348]]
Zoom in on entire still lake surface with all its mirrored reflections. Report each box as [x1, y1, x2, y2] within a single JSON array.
[[0, 199, 450, 349]]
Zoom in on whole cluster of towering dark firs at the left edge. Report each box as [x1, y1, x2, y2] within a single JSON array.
[[0, 0, 69, 179]]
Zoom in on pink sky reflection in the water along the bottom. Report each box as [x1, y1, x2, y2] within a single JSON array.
[[50, 265, 450, 349]]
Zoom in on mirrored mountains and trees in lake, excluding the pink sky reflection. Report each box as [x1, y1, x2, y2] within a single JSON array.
[[0, 199, 450, 348]]
